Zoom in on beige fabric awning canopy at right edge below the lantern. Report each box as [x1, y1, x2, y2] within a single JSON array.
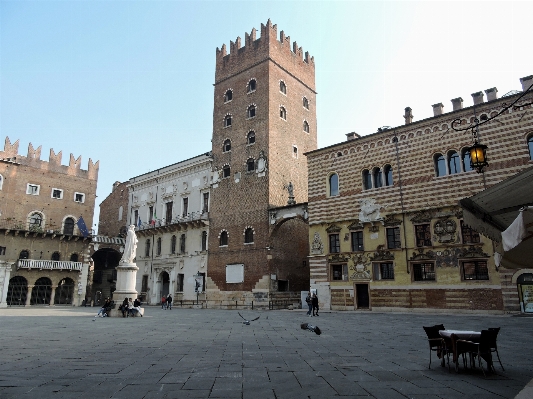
[[459, 167, 533, 269]]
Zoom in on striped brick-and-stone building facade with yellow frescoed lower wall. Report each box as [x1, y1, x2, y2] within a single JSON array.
[[306, 76, 533, 312]]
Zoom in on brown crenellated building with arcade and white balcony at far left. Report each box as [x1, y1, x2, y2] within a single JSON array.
[[0, 138, 98, 307]]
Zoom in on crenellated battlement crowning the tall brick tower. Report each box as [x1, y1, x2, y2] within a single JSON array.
[[215, 19, 315, 89]]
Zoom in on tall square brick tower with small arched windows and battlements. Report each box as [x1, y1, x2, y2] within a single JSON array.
[[207, 20, 317, 304]]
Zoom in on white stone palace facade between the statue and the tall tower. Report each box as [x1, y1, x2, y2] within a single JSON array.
[[126, 153, 212, 305]]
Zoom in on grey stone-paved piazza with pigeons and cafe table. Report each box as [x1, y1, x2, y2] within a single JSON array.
[[0, 307, 533, 399]]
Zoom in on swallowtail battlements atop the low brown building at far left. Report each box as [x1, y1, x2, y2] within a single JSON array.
[[0, 137, 100, 180]]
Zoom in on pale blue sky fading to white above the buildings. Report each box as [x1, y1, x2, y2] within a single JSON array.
[[0, 0, 533, 231]]
